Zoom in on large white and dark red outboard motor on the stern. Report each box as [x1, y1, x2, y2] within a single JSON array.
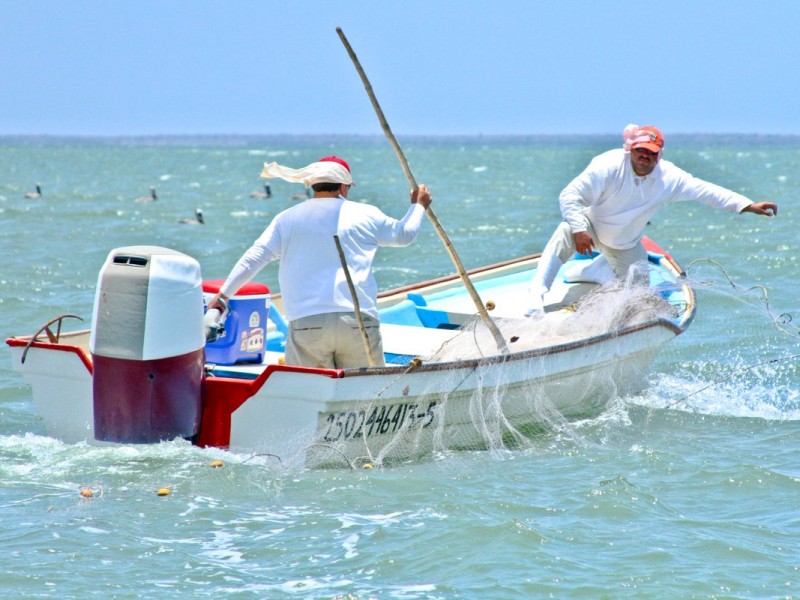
[[90, 246, 205, 443]]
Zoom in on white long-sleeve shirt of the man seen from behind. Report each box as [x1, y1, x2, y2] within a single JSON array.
[[220, 196, 425, 321]]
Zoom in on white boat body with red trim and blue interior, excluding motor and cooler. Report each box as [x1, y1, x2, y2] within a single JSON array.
[[7, 238, 696, 467]]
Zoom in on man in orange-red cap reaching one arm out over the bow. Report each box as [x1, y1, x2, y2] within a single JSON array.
[[526, 125, 778, 316]]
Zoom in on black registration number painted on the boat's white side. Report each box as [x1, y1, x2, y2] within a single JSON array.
[[323, 402, 436, 442]]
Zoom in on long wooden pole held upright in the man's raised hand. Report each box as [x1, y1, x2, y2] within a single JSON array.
[[336, 27, 508, 354]]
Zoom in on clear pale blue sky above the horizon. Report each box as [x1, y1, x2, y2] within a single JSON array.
[[0, 0, 800, 135]]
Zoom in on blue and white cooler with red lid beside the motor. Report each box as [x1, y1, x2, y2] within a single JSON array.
[[203, 279, 270, 365]]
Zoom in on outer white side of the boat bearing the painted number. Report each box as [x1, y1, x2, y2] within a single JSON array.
[[230, 316, 676, 466]]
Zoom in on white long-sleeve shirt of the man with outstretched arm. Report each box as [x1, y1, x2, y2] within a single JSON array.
[[559, 148, 752, 250]]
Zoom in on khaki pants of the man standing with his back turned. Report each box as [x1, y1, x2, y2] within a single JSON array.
[[286, 313, 386, 369]]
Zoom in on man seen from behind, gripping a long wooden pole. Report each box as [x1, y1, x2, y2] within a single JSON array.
[[208, 156, 431, 369]]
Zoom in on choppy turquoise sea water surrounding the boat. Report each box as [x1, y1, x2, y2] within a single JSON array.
[[0, 136, 800, 598]]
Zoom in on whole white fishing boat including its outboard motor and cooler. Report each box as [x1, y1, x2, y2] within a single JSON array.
[[6, 239, 696, 467]]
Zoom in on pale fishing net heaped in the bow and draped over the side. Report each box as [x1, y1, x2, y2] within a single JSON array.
[[286, 268, 681, 468]]
